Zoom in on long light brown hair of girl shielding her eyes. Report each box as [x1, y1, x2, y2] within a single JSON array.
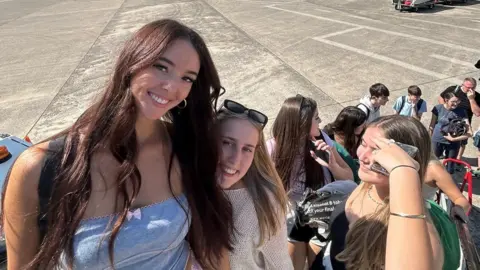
[[336, 115, 431, 270]]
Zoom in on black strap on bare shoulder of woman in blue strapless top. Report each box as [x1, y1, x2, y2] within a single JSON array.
[[37, 137, 65, 240]]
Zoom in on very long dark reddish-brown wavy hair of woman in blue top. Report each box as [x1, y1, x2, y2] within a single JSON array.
[[2, 20, 233, 269]]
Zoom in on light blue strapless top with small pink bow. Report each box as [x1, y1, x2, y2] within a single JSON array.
[[61, 195, 190, 270]]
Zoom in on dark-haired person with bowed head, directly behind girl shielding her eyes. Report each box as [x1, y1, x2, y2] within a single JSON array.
[[323, 106, 367, 184]]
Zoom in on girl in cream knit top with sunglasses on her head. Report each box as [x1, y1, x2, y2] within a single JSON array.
[[216, 100, 293, 270]]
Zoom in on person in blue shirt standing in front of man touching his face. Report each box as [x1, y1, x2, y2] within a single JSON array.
[[429, 92, 472, 174]]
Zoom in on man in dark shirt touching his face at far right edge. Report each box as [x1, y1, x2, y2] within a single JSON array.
[[438, 77, 480, 160]]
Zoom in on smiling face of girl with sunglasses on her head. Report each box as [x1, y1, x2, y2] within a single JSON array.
[[218, 118, 260, 189]]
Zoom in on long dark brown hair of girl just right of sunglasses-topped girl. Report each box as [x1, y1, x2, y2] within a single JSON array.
[[272, 95, 325, 192]]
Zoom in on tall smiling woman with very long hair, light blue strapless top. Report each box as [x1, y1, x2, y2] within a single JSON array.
[[2, 20, 232, 269]]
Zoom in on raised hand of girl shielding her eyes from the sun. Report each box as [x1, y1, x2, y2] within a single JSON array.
[[373, 138, 420, 173]]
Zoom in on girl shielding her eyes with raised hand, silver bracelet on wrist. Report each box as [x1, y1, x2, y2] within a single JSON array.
[[290, 115, 460, 270]]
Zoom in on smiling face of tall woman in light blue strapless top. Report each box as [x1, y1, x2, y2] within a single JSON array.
[[130, 39, 200, 120]]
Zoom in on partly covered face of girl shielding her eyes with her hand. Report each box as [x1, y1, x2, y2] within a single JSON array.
[[357, 127, 388, 185]]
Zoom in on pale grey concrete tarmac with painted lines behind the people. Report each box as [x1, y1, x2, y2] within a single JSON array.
[[0, 0, 480, 248]]
